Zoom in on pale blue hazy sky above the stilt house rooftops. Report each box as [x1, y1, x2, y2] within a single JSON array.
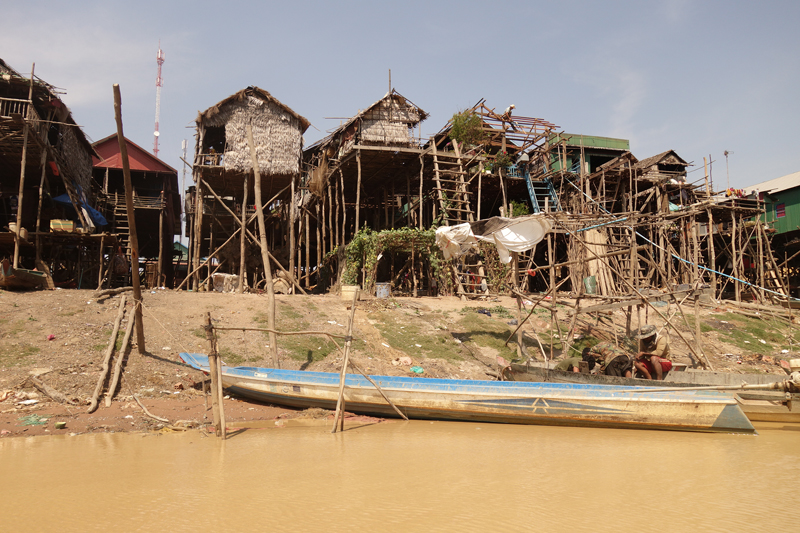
[[0, 0, 800, 189]]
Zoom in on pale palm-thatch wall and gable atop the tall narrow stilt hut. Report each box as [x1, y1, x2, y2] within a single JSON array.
[[197, 87, 309, 175]]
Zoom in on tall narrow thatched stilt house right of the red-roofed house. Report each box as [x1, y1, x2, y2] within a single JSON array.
[[187, 87, 309, 288]]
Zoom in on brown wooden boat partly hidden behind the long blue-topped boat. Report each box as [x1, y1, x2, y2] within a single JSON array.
[[503, 363, 800, 424]]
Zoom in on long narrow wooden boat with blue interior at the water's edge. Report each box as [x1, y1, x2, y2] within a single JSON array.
[[180, 353, 755, 433]]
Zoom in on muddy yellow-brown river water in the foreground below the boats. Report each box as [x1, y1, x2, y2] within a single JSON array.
[[0, 421, 800, 532]]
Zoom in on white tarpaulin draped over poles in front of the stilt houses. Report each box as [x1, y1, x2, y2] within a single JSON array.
[[436, 215, 552, 263]]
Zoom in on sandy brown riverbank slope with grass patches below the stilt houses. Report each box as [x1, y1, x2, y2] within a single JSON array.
[[0, 290, 792, 437]]
